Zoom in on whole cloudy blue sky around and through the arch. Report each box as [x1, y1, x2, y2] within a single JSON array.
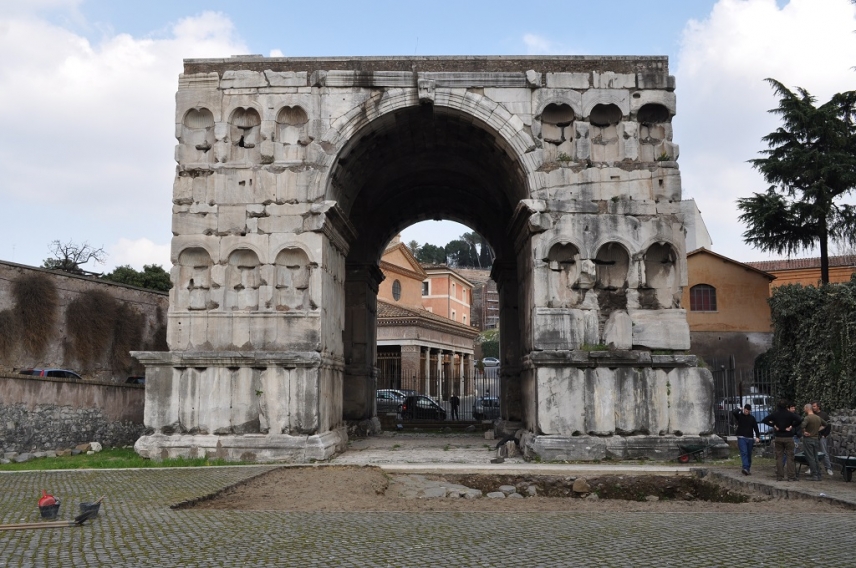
[[0, 0, 856, 271]]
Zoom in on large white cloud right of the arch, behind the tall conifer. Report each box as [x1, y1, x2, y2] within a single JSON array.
[[675, 0, 856, 261]]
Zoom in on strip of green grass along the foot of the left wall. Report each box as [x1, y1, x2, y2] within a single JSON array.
[[0, 448, 252, 471]]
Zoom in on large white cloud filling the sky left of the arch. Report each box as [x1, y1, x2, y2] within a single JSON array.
[[0, 10, 247, 263]]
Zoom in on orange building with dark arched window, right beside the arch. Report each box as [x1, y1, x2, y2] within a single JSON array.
[[681, 248, 775, 368]]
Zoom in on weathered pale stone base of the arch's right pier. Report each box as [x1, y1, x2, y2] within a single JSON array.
[[508, 350, 728, 461]]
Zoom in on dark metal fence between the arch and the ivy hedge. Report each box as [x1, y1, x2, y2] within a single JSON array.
[[711, 360, 777, 441]]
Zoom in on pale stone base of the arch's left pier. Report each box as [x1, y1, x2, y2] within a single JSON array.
[[133, 351, 348, 463]]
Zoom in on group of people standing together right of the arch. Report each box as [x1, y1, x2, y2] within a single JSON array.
[[734, 400, 832, 481]]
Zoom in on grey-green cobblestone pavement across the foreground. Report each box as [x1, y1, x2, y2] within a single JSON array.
[[0, 466, 856, 568]]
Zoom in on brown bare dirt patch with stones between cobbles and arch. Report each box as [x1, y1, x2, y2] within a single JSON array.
[[187, 466, 841, 513]]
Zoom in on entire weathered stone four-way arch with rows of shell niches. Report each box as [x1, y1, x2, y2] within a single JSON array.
[[134, 56, 724, 461]]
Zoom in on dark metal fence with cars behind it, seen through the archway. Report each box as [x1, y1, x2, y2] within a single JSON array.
[[377, 361, 500, 422]]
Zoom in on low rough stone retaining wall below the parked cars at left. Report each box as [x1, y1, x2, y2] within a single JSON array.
[[0, 376, 145, 454]]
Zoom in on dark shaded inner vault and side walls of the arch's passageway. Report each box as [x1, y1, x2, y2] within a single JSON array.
[[327, 104, 531, 420]]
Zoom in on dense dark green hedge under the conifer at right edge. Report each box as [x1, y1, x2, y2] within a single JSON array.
[[766, 274, 856, 409]]
